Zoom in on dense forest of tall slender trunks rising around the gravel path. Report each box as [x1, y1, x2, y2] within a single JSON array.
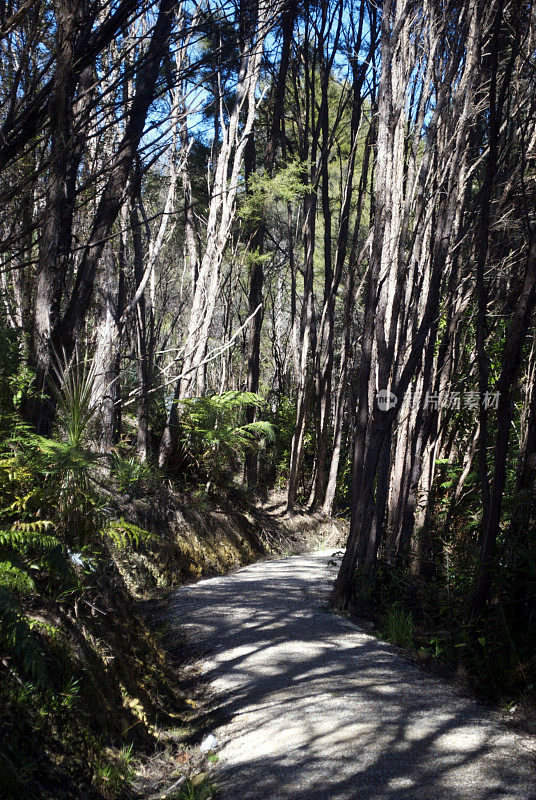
[[0, 0, 536, 797]]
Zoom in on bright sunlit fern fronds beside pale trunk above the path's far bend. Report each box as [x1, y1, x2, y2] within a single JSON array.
[[181, 391, 274, 484]]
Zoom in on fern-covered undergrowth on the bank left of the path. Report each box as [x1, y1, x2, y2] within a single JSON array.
[[0, 350, 188, 800]]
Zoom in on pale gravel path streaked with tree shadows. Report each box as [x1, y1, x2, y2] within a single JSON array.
[[172, 552, 536, 800]]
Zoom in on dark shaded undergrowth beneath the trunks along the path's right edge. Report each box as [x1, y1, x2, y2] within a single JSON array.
[[357, 532, 536, 705]]
